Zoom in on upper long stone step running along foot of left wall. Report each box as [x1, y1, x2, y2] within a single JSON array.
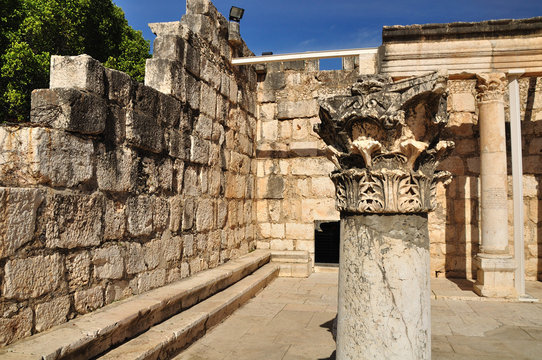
[[0, 250, 270, 360]]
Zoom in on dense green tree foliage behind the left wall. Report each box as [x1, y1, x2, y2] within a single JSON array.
[[0, 0, 150, 121]]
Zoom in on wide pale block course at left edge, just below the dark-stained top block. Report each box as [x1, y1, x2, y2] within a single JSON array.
[[0, 127, 94, 187]]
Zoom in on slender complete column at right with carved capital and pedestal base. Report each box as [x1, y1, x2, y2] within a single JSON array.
[[474, 73, 517, 297]]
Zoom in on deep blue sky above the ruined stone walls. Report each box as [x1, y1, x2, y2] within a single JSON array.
[[113, 0, 542, 55]]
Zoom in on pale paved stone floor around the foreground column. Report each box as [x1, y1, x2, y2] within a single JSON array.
[[175, 273, 542, 360]]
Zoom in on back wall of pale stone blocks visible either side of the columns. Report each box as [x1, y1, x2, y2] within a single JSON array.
[[256, 66, 542, 280]]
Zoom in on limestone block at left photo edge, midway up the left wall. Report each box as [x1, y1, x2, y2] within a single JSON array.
[[0, 188, 44, 259]]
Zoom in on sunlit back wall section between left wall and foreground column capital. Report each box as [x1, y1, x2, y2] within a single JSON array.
[[256, 61, 357, 261]]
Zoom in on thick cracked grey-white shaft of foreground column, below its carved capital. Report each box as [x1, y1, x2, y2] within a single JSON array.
[[337, 214, 431, 360]]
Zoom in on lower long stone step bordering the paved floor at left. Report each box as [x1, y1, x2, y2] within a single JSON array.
[[98, 264, 279, 360]]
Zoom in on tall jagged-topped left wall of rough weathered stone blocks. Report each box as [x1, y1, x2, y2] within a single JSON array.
[[0, 1, 256, 345]]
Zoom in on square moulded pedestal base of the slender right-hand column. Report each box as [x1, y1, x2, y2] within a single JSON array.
[[474, 254, 518, 298]]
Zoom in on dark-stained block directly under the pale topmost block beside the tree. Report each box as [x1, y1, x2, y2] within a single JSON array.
[[30, 88, 107, 134]]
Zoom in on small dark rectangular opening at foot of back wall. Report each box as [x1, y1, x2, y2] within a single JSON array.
[[314, 221, 341, 266]]
